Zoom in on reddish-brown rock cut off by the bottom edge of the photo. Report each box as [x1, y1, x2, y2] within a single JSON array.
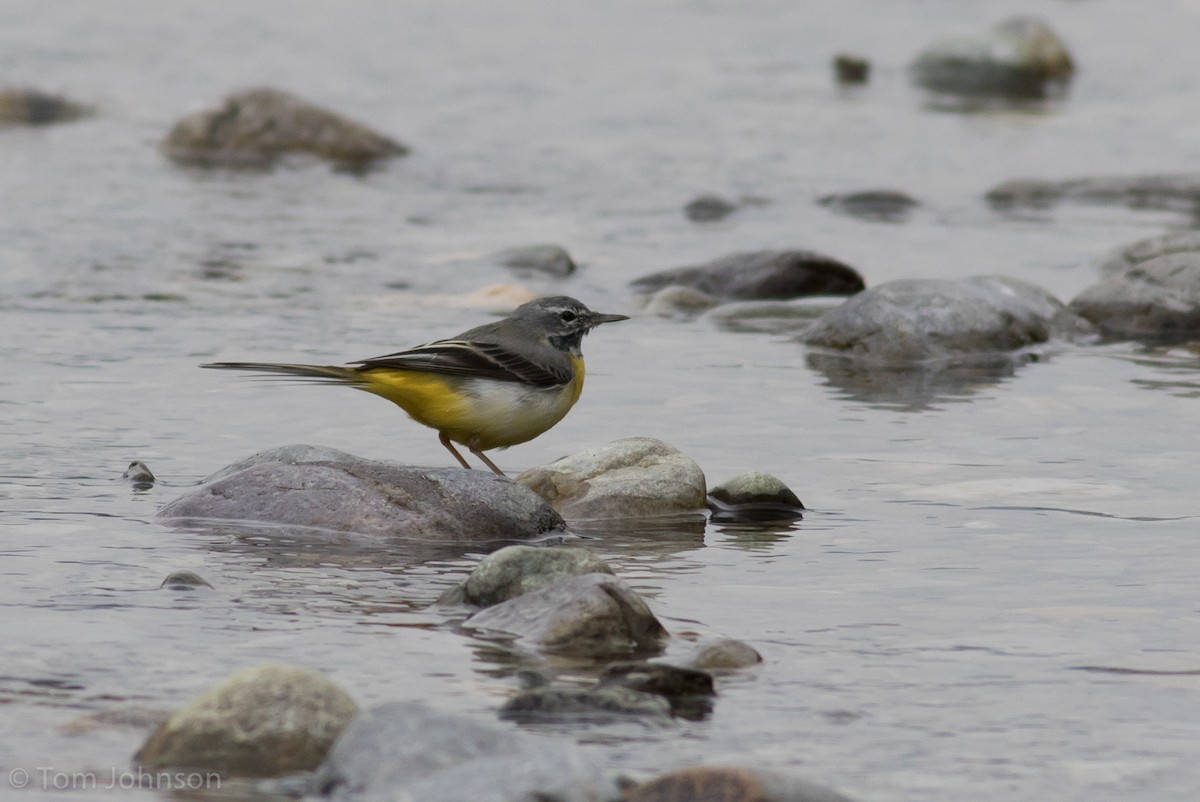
[[620, 766, 851, 802]]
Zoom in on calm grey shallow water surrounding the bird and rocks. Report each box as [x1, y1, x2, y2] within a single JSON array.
[[0, 0, 1200, 802]]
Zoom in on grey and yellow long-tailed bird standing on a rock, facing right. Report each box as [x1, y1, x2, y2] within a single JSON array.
[[202, 295, 629, 477]]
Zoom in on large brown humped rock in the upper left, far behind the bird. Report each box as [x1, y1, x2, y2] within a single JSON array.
[[161, 88, 408, 167]]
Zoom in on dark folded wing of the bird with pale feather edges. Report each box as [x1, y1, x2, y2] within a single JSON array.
[[355, 340, 571, 388]]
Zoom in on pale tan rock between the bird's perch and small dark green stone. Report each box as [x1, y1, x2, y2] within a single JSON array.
[[516, 437, 706, 520]]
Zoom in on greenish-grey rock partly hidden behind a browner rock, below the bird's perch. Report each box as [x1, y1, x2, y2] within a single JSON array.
[[438, 546, 612, 608]]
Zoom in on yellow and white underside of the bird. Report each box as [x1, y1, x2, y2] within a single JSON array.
[[358, 354, 584, 451]]
